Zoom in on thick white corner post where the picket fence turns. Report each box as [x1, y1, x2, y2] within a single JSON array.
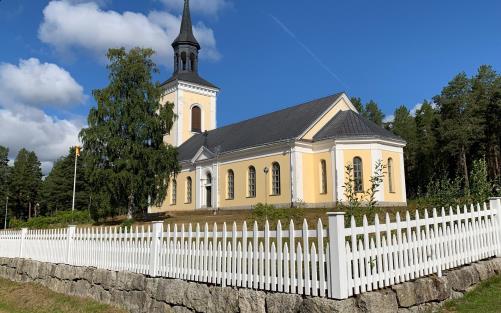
[[327, 212, 348, 299]]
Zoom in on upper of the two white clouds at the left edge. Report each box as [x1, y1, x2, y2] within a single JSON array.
[[0, 58, 85, 107]]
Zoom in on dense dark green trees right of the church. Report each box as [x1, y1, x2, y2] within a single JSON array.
[[382, 65, 501, 201]]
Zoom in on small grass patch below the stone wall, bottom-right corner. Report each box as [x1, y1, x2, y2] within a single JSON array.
[[441, 276, 501, 313]]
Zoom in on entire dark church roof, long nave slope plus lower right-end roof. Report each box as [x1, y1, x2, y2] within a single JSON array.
[[178, 93, 403, 161]]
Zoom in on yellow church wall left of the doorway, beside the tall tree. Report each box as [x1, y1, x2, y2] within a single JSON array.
[[150, 170, 197, 213]]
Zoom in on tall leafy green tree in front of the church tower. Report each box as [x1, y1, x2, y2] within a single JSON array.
[[80, 48, 179, 218]]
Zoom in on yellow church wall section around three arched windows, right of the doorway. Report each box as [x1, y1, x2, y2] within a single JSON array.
[[218, 154, 291, 208]]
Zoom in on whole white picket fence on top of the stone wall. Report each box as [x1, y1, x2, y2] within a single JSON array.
[[0, 198, 501, 299]]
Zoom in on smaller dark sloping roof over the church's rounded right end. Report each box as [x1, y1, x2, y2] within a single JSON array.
[[313, 110, 404, 142]]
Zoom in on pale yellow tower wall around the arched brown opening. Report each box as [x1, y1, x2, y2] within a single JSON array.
[[183, 90, 215, 142]]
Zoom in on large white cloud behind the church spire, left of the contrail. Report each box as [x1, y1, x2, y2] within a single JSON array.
[[38, 1, 219, 67]]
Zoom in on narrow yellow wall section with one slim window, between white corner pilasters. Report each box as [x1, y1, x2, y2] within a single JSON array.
[[302, 151, 334, 203]]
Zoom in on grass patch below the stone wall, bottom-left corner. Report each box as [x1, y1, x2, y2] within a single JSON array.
[[0, 278, 125, 313]]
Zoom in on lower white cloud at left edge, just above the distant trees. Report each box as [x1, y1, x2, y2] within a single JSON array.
[[0, 105, 83, 175]]
